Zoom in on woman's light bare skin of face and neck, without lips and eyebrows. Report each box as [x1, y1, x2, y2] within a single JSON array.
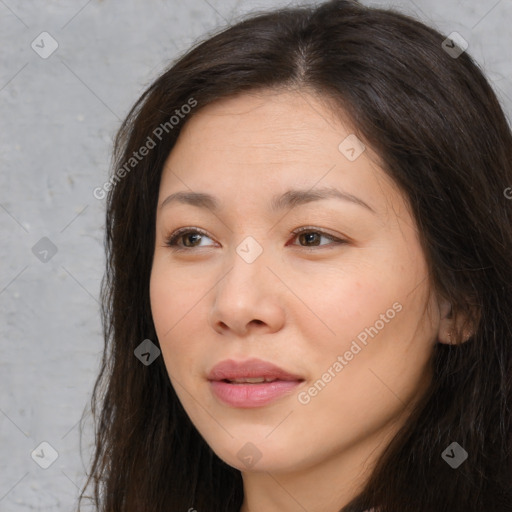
[[150, 90, 460, 512]]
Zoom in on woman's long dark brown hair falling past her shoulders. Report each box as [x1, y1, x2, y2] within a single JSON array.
[[76, 0, 512, 512]]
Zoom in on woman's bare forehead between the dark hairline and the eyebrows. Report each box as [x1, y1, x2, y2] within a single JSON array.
[[161, 91, 403, 220]]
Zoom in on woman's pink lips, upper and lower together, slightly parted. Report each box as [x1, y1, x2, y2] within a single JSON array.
[[208, 359, 304, 408]]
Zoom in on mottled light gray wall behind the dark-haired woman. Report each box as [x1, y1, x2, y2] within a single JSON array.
[[0, 0, 512, 512]]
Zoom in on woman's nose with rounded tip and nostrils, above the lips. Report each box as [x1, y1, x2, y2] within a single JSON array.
[[209, 246, 286, 337]]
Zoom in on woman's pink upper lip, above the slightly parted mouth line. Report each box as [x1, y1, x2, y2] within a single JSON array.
[[207, 359, 304, 381]]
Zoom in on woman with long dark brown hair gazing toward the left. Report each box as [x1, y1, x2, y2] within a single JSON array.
[[77, 0, 512, 512]]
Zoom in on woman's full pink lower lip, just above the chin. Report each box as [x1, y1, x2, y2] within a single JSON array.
[[210, 380, 302, 408]]
